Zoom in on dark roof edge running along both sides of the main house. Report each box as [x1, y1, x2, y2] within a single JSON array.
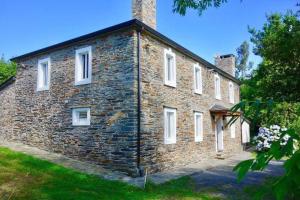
[[11, 19, 240, 84]]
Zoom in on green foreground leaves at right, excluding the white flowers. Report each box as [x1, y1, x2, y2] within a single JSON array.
[[229, 100, 300, 200]]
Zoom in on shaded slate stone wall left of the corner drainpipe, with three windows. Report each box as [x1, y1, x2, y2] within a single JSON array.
[[10, 31, 137, 175]]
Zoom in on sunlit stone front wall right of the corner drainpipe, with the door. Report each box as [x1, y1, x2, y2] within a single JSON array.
[[141, 33, 242, 172]]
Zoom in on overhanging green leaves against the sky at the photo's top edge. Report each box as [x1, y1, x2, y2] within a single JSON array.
[[173, 0, 227, 15]]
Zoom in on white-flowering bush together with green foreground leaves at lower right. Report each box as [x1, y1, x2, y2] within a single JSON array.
[[228, 100, 300, 200]]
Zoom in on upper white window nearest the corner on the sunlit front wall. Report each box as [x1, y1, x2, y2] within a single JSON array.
[[164, 49, 176, 87]]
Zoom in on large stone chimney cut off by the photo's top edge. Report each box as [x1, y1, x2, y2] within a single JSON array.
[[132, 0, 156, 29]]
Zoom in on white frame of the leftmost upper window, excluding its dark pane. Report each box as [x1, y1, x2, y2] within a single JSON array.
[[37, 57, 51, 91]]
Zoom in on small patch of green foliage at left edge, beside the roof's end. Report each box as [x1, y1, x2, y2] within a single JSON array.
[[0, 57, 17, 85]]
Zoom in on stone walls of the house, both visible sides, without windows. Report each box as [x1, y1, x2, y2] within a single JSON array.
[[0, 20, 242, 176]]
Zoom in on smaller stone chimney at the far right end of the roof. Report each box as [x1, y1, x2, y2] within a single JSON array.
[[215, 54, 235, 77]]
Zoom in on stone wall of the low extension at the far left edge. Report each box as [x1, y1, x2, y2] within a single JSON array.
[[0, 83, 15, 140]]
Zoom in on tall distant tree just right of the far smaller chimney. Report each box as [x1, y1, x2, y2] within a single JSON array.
[[235, 41, 253, 79]]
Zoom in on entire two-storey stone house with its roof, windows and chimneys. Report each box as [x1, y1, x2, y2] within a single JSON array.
[[0, 0, 242, 176]]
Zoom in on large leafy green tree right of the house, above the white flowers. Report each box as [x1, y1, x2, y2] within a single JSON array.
[[249, 12, 300, 102]]
